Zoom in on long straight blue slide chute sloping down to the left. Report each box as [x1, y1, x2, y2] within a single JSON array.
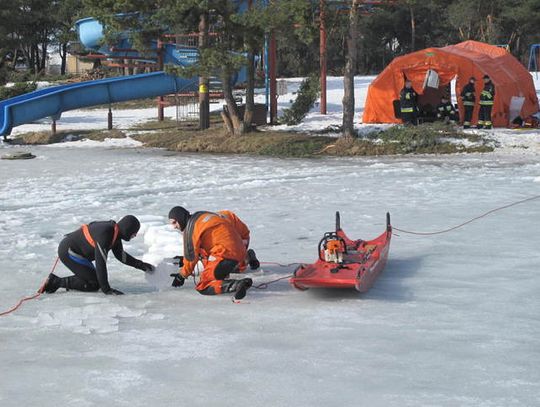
[[0, 72, 199, 135]]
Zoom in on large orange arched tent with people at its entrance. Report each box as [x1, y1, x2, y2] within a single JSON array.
[[363, 41, 538, 127]]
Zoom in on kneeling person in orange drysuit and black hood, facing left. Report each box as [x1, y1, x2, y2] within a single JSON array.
[[169, 206, 253, 300]]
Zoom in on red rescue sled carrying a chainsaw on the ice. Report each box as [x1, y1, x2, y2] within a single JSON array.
[[290, 212, 392, 292]]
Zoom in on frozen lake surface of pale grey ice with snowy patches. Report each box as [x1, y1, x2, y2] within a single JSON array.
[[0, 147, 540, 407]]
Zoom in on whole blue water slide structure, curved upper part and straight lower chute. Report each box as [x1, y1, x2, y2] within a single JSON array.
[[0, 18, 251, 139]]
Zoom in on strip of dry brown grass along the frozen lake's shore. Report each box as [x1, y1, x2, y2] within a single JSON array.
[[3, 118, 497, 158]]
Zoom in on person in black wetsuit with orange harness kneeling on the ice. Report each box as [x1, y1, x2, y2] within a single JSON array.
[[43, 215, 154, 295]]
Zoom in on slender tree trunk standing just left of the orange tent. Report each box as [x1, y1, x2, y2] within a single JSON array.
[[343, 0, 358, 138]]
